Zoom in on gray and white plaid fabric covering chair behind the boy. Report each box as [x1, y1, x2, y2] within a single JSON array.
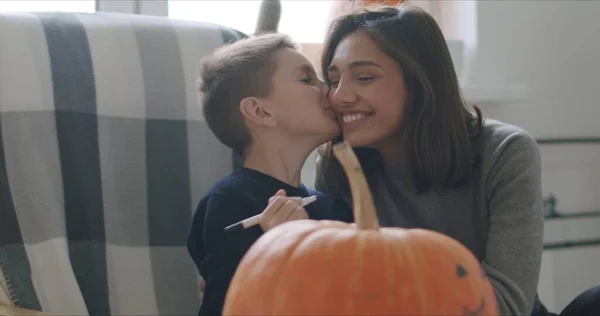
[[0, 13, 243, 315]]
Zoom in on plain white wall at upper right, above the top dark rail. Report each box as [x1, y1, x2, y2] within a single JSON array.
[[467, 0, 600, 137]]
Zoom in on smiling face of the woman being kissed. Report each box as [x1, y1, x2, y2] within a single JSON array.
[[327, 31, 408, 148]]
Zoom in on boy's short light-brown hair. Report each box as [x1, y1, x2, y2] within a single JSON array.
[[198, 33, 297, 156]]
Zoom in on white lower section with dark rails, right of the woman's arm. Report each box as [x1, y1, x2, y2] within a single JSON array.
[[538, 141, 600, 313]]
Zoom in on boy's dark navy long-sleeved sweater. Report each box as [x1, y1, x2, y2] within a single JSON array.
[[187, 168, 352, 316]]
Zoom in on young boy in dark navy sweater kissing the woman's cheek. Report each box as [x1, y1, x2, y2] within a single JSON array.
[[188, 34, 352, 315]]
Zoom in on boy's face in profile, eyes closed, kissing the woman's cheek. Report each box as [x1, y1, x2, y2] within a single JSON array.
[[262, 48, 340, 145]]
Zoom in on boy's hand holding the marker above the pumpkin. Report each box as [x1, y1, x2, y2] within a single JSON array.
[[260, 190, 308, 232]]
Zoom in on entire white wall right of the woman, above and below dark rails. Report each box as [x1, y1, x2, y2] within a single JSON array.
[[467, 0, 600, 312]]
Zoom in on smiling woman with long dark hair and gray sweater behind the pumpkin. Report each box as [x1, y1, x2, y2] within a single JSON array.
[[316, 7, 596, 315]]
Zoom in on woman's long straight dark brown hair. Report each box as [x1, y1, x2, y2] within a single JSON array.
[[317, 6, 483, 198]]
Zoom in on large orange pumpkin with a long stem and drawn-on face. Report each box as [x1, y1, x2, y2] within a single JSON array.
[[223, 143, 497, 315]]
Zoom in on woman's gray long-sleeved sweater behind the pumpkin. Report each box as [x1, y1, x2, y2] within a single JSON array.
[[317, 119, 543, 315]]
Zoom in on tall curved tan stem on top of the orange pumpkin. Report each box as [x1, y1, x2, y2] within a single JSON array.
[[333, 141, 379, 230]]
